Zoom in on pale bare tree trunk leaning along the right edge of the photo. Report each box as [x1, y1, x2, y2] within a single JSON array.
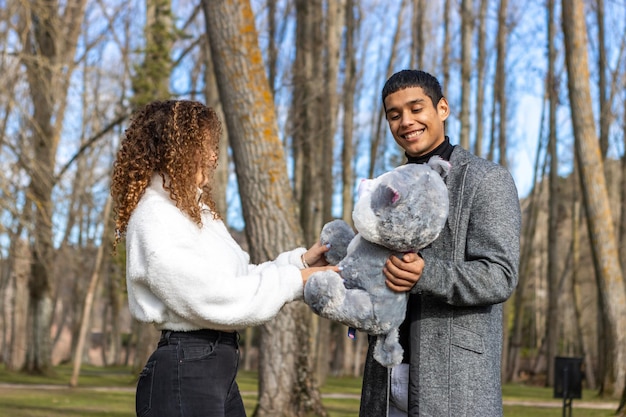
[[562, 0, 626, 397]]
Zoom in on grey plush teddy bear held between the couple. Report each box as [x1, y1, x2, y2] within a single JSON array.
[[304, 156, 450, 367]]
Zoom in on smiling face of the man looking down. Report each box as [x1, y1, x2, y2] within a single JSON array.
[[385, 87, 450, 157]]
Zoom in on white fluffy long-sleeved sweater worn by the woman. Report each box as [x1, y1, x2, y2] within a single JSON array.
[[126, 176, 305, 331]]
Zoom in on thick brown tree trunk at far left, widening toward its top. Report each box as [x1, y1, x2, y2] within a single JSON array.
[[19, 0, 85, 374]]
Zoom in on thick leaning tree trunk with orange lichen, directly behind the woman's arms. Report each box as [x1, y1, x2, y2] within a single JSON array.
[[202, 0, 325, 417]]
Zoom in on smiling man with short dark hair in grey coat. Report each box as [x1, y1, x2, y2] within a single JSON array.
[[359, 70, 521, 417]]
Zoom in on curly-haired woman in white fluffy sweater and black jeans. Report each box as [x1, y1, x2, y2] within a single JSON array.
[[111, 100, 336, 417]]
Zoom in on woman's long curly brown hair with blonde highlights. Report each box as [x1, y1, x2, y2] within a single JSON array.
[[111, 100, 222, 249]]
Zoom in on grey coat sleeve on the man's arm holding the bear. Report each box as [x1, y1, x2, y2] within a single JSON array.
[[413, 164, 521, 306]]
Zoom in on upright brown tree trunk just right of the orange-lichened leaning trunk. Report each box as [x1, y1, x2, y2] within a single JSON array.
[[290, 0, 324, 388]]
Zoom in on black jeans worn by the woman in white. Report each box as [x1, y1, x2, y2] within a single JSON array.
[[136, 330, 246, 417]]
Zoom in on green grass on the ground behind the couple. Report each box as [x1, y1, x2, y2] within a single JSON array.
[[0, 365, 617, 417]]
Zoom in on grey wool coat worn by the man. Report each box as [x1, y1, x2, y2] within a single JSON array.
[[359, 146, 521, 417]]
